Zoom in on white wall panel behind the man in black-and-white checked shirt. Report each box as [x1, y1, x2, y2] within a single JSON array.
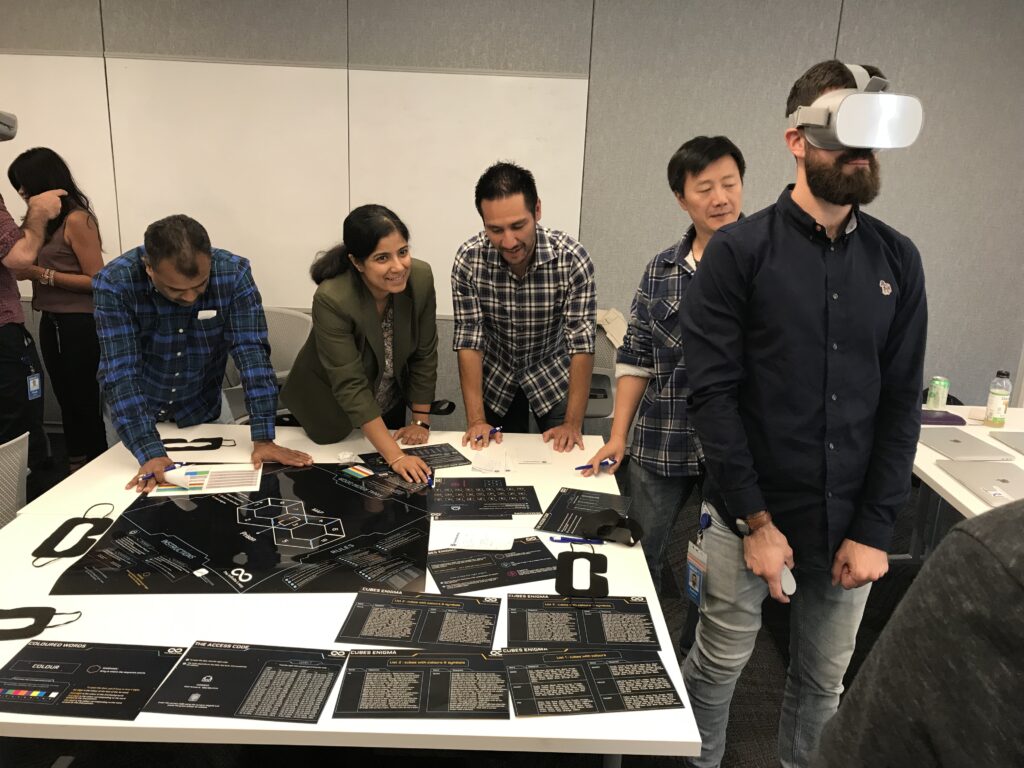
[[349, 70, 587, 315]]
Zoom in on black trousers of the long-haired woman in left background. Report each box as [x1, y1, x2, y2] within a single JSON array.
[[39, 312, 106, 461]]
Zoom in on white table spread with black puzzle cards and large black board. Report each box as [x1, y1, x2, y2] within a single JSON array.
[[0, 424, 700, 766]]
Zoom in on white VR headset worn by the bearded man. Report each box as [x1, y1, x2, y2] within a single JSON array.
[[790, 65, 925, 150]]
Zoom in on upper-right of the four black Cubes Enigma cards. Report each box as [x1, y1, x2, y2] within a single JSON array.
[[507, 595, 660, 650]]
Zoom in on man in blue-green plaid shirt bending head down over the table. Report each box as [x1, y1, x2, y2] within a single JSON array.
[[92, 215, 312, 492]]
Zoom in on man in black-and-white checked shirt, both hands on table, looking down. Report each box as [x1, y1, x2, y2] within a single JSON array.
[[452, 163, 596, 451]]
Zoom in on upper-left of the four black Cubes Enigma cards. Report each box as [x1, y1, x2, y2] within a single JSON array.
[[335, 590, 502, 651]]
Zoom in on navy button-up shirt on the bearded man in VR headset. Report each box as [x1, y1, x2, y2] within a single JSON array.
[[682, 187, 928, 568]]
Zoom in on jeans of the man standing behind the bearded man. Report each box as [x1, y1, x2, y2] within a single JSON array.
[[629, 459, 699, 597]]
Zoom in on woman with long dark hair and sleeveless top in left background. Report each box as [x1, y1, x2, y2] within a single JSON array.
[[7, 146, 106, 472]]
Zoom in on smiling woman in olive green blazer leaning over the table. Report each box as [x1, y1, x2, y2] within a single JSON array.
[[281, 205, 437, 482]]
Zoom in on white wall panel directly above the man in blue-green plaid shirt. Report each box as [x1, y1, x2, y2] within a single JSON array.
[[108, 58, 348, 308]]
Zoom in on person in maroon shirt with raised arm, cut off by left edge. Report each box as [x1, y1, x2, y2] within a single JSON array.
[[0, 112, 67, 479]]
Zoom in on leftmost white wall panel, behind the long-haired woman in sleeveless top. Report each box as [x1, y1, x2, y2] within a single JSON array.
[[0, 54, 121, 295]]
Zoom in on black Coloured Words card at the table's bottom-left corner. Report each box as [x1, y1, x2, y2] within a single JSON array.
[[0, 640, 184, 720]]
